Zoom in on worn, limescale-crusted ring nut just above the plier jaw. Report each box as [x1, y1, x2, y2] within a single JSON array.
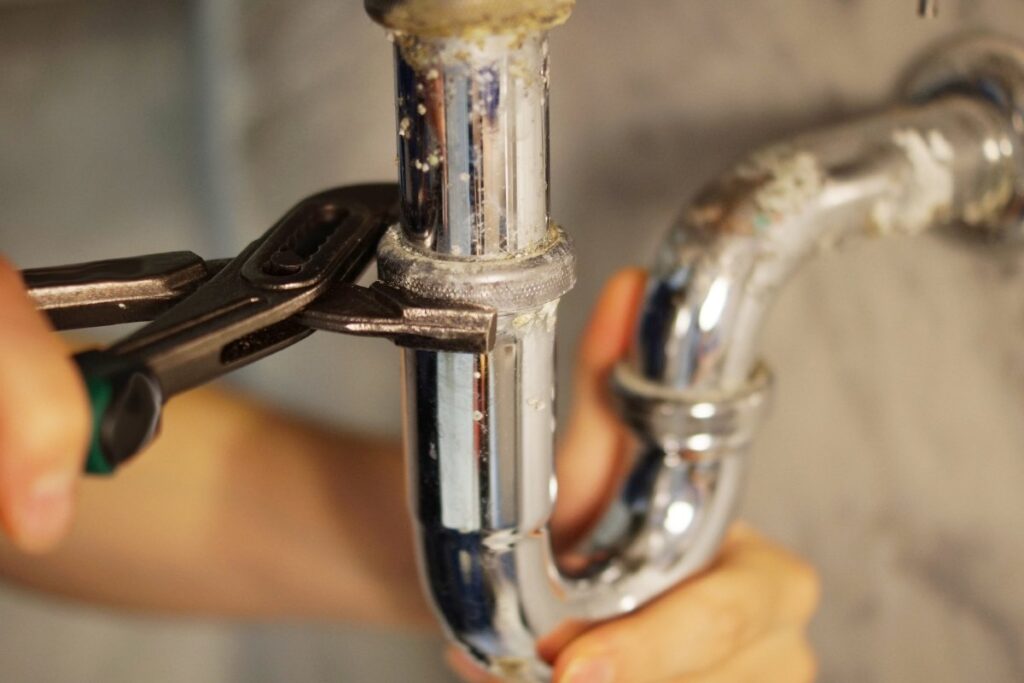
[[377, 224, 575, 312]]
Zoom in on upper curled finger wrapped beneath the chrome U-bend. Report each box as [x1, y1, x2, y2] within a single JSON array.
[[555, 526, 818, 683]]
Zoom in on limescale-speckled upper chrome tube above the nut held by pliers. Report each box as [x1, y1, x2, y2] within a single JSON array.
[[395, 33, 548, 253]]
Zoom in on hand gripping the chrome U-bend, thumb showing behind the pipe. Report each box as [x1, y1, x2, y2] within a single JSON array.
[[449, 270, 819, 683]]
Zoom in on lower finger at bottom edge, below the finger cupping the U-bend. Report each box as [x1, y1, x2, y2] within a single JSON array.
[[675, 629, 818, 683]]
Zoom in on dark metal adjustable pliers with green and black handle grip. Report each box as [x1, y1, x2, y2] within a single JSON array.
[[23, 184, 496, 474]]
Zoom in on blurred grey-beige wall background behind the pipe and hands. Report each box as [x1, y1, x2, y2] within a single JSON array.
[[0, 0, 1024, 683]]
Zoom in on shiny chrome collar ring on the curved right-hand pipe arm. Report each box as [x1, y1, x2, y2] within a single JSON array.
[[611, 362, 774, 462]]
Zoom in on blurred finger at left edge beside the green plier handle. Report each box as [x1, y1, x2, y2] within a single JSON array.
[[0, 259, 89, 552]]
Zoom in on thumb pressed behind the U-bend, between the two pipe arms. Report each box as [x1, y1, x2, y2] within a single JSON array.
[[552, 268, 646, 547]]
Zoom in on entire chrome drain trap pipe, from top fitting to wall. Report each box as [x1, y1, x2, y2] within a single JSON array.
[[367, 0, 1024, 681]]
